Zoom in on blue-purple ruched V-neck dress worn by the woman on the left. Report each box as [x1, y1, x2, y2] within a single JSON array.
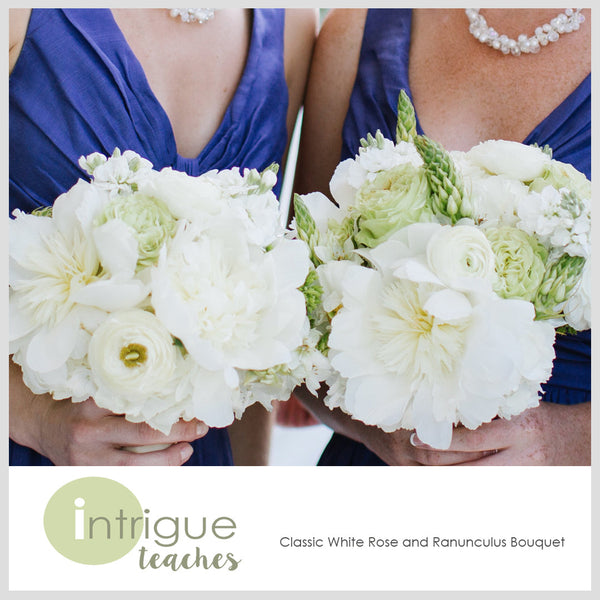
[[9, 9, 288, 465]]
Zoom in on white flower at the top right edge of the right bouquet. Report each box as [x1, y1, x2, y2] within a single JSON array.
[[466, 140, 552, 182]]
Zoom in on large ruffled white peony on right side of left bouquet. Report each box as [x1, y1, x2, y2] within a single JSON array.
[[152, 219, 310, 412]]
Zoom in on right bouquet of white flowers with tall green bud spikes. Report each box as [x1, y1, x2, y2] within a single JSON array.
[[292, 92, 591, 449]]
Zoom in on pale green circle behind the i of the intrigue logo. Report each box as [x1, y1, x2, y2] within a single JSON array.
[[44, 477, 144, 565]]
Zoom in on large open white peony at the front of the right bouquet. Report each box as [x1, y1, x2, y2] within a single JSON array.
[[328, 236, 554, 448]]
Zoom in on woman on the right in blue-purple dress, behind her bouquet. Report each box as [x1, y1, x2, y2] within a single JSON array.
[[296, 9, 591, 465]]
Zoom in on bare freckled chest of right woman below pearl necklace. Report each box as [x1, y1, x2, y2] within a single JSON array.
[[409, 9, 591, 150]]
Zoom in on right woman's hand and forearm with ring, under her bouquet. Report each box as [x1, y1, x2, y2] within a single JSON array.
[[365, 402, 591, 466]]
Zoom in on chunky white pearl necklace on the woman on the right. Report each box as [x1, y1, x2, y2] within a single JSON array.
[[465, 8, 585, 56]]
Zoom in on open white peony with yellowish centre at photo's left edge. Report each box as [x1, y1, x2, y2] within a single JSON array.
[[9, 181, 148, 373]]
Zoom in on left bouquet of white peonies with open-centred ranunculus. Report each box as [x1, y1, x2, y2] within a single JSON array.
[[9, 149, 326, 433]]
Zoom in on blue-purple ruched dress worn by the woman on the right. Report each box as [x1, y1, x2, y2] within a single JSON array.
[[319, 9, 591, 466]]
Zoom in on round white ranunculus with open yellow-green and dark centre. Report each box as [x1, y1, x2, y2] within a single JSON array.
[[88, 309, 181, 433]]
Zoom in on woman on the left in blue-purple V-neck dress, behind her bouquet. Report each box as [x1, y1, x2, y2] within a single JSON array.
[[9, 9, 316, 465]]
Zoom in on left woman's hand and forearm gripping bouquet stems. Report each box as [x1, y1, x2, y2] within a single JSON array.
[[10, 361, 208, 466]]
